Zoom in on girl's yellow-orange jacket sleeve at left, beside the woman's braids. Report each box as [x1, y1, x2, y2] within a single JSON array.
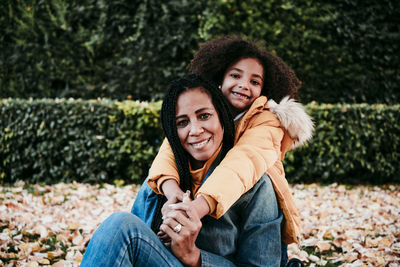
[[147, 138, 179, 194]]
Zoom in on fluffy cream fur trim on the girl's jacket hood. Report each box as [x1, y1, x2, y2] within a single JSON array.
[[268, 96, 314, 148]]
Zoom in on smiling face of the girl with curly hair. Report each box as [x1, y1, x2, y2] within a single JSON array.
[[221, 58, 264, 113]]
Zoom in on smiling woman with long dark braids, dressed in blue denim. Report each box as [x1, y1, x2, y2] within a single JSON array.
[[81, 75, 282, 266]]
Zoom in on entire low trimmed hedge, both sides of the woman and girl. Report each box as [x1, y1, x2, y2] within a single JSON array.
[[0, 99, 400, 184]]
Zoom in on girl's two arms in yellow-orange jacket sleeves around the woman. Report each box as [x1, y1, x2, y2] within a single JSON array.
[[148, 111, 284, 218]]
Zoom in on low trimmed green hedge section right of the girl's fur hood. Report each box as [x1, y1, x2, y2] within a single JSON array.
[[285, 103, 400, 184]]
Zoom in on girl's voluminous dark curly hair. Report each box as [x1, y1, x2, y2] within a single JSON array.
[[188, 35, 301, 103]]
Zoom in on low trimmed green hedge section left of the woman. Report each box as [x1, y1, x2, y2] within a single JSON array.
[[0, 99, 162, 183]]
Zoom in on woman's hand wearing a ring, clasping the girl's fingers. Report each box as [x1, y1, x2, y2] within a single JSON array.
[[160, 193, 202, 266]]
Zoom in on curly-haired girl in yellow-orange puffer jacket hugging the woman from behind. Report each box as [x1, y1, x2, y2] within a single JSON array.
[[148, 36, 313, 255]]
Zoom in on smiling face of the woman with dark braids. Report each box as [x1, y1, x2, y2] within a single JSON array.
[[176, 87, 223, 168]]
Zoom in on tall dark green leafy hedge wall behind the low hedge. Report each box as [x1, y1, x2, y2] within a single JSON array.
[[0, 0, 400, 104]]
